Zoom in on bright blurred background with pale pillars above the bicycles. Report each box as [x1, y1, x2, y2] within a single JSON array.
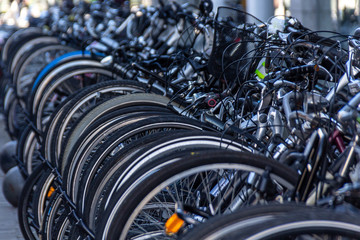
[[0, 0, 360, 34]]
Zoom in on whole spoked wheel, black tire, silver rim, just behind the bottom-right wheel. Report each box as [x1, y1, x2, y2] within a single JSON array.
[[95, 150, 297, 239]]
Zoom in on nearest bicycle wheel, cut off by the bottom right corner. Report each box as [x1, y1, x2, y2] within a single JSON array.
[[191, 208, 360, 240]]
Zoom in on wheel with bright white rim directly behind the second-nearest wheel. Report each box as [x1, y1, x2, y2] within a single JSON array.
[[81, 129, 247, 228]]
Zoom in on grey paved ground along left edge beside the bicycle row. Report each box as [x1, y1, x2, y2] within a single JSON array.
[[0, 115, 23, 240]]
